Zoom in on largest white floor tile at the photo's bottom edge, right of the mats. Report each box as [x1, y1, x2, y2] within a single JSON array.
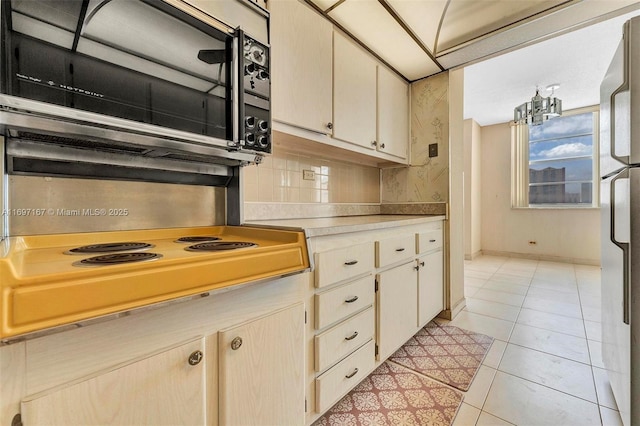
[[483, 371, 600, 426]]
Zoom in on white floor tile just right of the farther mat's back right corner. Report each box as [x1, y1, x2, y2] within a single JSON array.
[[509, 324, 589, 364]]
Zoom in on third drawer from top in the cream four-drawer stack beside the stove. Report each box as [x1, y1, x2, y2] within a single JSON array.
[[315, 307, 375, 371]]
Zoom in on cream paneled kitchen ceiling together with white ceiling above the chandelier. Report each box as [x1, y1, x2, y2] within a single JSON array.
[[305, 0, 640, 126]]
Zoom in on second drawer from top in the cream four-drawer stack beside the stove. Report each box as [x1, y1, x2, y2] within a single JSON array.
[[315, 275, 374, 330]]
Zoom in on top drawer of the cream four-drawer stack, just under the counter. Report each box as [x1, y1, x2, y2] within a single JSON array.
[[316, 243, 374, 287]]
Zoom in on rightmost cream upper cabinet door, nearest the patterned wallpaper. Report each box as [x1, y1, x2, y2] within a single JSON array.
[[376, 66, 409, 159]]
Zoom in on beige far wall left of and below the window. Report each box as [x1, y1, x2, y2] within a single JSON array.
[[480, 123, 600, 264]]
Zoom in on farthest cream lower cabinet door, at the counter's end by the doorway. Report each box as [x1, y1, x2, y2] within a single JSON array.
[[417, 249, 444, 327]]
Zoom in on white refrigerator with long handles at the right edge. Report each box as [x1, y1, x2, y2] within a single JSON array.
[[600, 13, 640, 426]]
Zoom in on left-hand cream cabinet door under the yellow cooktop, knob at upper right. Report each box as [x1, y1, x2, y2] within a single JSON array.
[[21, 339, 205, 426]]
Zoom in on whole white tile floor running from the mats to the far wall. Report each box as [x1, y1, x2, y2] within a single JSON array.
[[451, 256, 622, 426]]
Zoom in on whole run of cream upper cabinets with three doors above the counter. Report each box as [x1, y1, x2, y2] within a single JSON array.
[[269, 0, 409, 164]]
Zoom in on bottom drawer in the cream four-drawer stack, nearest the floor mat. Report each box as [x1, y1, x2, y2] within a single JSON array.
[[316, 340, 375, 413]]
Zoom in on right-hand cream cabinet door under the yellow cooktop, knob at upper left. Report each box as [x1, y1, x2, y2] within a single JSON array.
[[218, 303, 305, 426]]
